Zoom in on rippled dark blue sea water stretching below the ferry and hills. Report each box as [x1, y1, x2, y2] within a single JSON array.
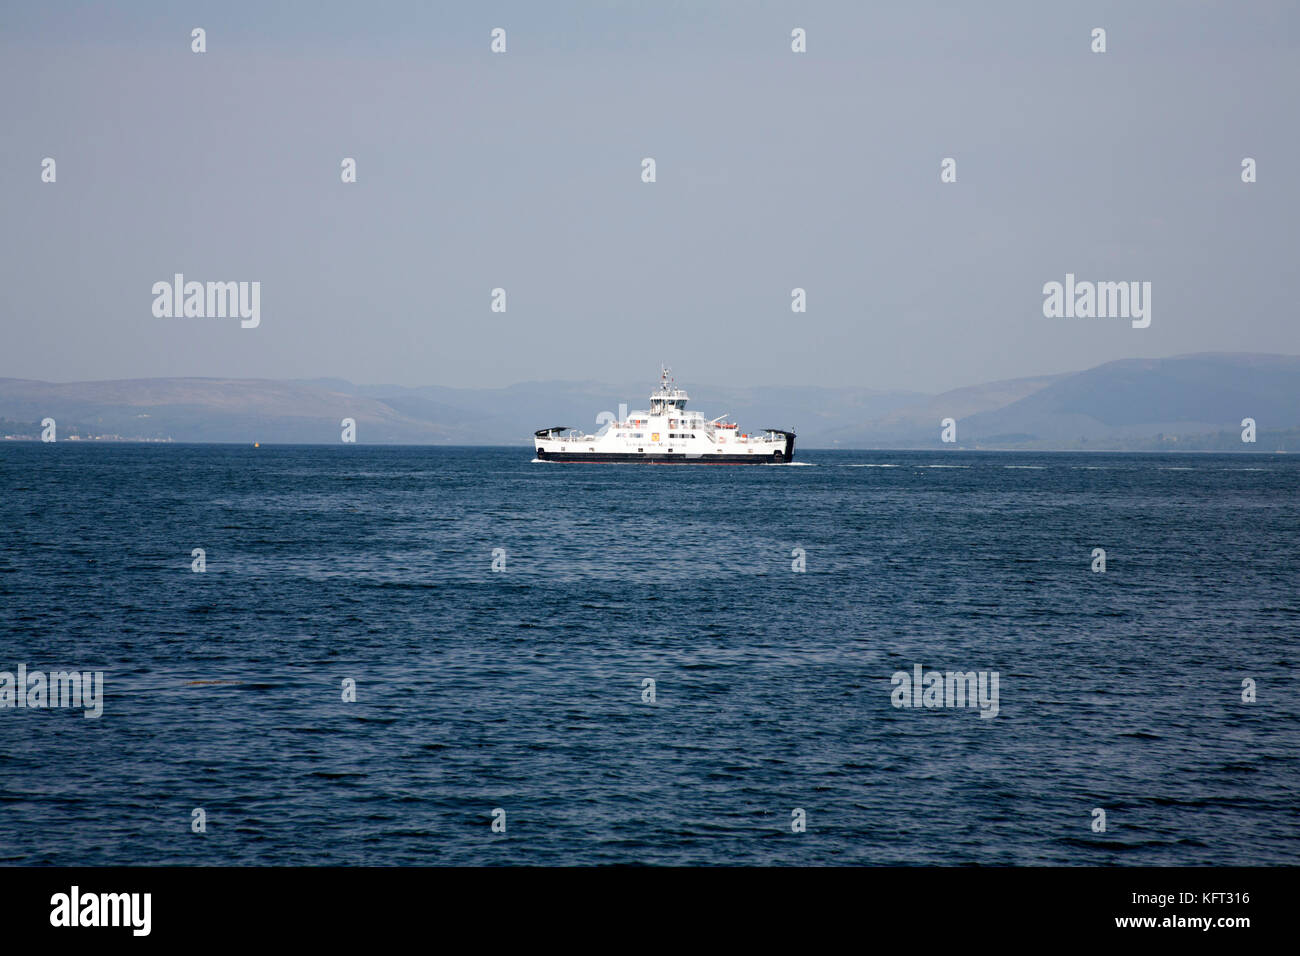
[[0, 442, 1300, 865]]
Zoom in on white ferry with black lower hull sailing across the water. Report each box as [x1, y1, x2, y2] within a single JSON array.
[[533, 368, 794, 464]]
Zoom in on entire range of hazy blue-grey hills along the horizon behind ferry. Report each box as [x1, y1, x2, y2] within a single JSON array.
[[0, 352, 1300, 451]]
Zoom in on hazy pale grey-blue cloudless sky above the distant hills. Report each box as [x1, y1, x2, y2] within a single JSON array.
[[0, 0, 1300, 390]]
